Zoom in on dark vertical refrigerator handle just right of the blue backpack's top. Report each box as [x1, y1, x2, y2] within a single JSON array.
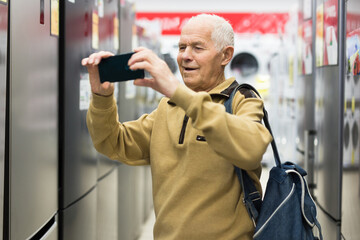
[[304, 130, 316, 195]]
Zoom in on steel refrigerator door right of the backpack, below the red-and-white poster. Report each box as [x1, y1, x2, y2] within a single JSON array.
[[314, 55, 343, 239]]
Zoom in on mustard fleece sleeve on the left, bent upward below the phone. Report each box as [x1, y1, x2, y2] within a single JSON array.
[[86, 94, 156, 165]]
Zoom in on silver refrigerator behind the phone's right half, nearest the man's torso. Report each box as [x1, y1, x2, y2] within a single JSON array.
[[118, 1, 144, 240]]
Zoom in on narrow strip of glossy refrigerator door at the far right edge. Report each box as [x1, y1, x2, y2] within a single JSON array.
[[341, 0, 360, 239]]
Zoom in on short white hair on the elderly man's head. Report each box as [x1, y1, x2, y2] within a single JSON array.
[[188, 13, 234, 52]]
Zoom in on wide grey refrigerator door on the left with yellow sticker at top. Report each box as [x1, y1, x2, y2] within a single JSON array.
[[5, 0, 59, 239]]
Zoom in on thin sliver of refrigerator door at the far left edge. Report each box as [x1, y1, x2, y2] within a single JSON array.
[[0, 2, 8, 239]]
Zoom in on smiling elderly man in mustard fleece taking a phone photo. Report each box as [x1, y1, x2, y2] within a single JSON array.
[[82, 14, 271, 240]]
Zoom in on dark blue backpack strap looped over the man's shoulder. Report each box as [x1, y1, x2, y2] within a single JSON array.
[[224, 83, 281, 226]]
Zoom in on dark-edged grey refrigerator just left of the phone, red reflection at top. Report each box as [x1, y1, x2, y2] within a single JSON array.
[[59, 0, 98, 240]]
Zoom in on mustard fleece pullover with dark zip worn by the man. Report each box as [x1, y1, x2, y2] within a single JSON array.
[[87, 78, 272, 240]]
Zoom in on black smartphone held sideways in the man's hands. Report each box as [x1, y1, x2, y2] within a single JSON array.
[[99, 52, 145, 83]]
